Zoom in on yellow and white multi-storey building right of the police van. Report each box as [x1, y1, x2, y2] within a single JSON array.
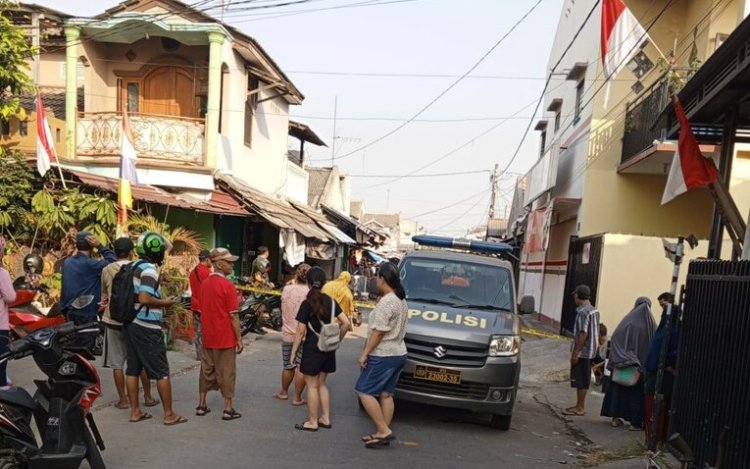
[[510, 0, 750, 330]]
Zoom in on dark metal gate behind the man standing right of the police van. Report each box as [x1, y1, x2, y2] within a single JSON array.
[[560, 235, 604, 334]]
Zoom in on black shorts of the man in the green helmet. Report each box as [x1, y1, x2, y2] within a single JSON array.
[[125, 324, 169, 380]]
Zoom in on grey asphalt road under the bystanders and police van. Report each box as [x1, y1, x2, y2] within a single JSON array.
[[57, 334, 588, 469]]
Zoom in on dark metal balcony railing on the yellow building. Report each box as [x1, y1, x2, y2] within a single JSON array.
[[621, 78, 670, 163]]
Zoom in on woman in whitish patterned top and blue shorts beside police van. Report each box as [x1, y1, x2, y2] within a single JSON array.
[[354, 262, 409, 448]]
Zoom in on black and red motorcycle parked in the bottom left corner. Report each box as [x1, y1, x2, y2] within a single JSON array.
[[0, 322, 106, 469]]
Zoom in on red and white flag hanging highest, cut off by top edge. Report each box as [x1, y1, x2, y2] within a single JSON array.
[[601, 0, 648, 108]]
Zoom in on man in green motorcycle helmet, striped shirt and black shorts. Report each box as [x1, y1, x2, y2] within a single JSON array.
[[125, 231, 187, 425]]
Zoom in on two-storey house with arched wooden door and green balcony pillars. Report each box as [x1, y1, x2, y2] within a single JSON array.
[[4, 0, 346, 278]]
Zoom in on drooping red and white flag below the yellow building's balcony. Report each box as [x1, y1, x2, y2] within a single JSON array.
[[661, 100, 719, 205]]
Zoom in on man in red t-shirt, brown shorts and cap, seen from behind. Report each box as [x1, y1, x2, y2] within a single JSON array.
[[195, 248, 243, 420]]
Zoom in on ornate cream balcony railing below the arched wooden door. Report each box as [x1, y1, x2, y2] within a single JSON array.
[[76, 112, 205, 166]]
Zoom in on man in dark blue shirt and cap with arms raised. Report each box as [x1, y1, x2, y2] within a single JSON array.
[[60, 231, 117, 324]]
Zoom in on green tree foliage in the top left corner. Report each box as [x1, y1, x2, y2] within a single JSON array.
[[0, 0, 34, 119]]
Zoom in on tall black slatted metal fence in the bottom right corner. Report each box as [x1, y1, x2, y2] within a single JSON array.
[[671, 260, 750, 469]]
